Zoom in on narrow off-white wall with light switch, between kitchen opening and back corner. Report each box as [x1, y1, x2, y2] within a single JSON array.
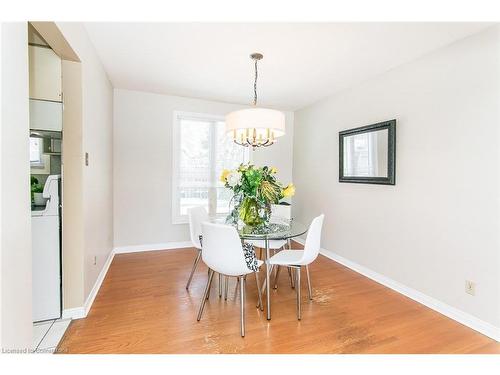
[[57, 22, 113, 307]]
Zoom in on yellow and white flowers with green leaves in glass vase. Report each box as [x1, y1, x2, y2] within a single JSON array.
[[220, 164, 295, 226]]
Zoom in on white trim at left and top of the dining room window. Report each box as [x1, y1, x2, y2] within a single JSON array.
[[171, 111, 252, 224]]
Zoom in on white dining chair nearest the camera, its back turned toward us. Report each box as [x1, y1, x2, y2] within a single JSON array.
[[197, 222, 263, 337]]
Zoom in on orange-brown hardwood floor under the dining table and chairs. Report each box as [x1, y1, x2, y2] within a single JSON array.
[[58, 245, 500, 354]]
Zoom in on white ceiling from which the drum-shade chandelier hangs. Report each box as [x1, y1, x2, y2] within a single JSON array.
[[85, 22, 489, 110]]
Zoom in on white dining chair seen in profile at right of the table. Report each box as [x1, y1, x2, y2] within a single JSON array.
[[269, 214, 325, 320]]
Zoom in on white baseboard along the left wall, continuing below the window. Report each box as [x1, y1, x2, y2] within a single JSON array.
[[62, 241, 193, 319]]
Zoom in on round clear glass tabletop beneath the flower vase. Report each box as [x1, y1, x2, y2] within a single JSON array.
[[215, 219, 308, 240]]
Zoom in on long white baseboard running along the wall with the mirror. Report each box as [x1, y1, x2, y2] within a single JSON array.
[[294, 238, 500, 341]]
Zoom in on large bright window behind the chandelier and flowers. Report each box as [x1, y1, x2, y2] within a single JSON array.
[[172, 112, 250, 224]]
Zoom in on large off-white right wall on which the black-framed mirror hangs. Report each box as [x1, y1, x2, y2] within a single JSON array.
[[293, 27, 500, 327]]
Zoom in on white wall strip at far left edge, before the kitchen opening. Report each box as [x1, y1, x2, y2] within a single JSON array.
[[0, 22, 32, 350]]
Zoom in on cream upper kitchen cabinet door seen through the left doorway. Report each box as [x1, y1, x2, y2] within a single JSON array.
[[28, 46, 62, 102]]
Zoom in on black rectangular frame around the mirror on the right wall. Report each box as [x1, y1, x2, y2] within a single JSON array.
[[339, 119, 396, 185]]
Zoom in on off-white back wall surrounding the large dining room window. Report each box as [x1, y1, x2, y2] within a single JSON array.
[[114, 89, 293, 247]]
